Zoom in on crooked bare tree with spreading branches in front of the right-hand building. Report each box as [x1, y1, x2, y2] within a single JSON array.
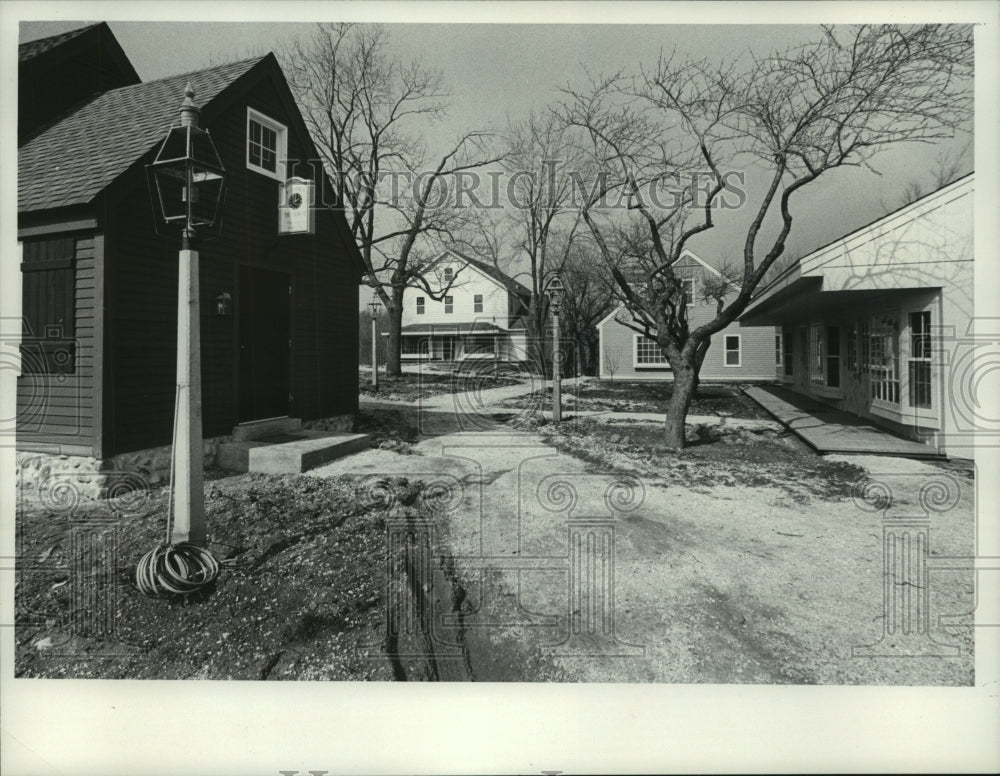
[[558, 25, 973, 450]]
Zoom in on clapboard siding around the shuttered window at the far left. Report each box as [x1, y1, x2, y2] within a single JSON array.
[[17, 232, 97, 454]]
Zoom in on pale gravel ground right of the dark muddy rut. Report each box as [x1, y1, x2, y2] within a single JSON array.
[[312, 398, 974, 686]]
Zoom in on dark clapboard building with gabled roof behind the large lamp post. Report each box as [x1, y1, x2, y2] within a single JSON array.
[[17, 23, 361, 478]]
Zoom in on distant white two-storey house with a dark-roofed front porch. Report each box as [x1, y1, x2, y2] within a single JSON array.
[[401, 250, 531, 361]]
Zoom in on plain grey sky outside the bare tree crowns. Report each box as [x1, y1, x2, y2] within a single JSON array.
[[20, 14, 973, 270]]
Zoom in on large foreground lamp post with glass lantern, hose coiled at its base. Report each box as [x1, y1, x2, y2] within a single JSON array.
[[146, 83, 226, 547]]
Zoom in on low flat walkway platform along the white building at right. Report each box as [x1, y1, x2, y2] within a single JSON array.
[[745, 385, 946, 460]]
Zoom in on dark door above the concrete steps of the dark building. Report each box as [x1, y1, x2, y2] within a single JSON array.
[[238, 266, 291, 423]]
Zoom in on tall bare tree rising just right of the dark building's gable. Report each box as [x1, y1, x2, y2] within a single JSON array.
[[282, 24, 501, 375]]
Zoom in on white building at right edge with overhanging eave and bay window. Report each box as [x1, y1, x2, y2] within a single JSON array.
[[740, 174, 972, 457]]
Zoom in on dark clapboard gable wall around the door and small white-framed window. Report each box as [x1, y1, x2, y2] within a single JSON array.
[[104, 71, 359, 454]]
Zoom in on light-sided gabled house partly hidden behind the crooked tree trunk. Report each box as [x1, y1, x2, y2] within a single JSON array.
[[597, 250, 781, 382]]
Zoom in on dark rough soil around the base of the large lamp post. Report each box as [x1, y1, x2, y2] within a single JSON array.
[[15, 466, 406, 679]]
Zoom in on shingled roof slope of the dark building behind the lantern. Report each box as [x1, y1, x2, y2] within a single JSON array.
[[17, 55, 263, 213]]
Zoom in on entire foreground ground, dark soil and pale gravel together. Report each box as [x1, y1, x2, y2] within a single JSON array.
[[16, 378, 975, 686]]
